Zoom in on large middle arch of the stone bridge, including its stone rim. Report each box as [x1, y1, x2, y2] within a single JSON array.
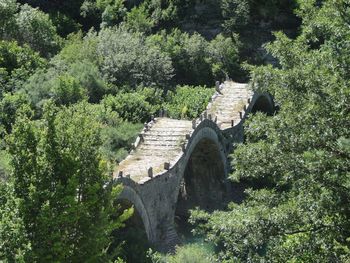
[[174, 120, 228, 235]]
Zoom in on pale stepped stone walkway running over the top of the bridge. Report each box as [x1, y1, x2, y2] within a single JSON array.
[[114, 82, 253, 184]]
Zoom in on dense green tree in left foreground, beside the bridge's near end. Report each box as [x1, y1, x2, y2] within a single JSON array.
[[8, 102, 132, 262]]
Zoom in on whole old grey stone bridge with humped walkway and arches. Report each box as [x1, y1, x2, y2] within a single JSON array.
[[114, 81, 274, 251]]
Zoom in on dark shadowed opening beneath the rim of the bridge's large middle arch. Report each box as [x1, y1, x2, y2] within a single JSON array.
[[175, 138, 228, 238]]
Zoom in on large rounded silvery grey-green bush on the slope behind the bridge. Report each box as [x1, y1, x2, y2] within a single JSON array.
[[97, 27, 173, 87]]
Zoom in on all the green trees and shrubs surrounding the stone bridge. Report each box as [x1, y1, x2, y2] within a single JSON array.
[[0, 0, 350, 262]]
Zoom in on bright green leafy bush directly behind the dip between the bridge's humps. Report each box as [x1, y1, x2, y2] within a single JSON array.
[[164, 86, 214, 119]]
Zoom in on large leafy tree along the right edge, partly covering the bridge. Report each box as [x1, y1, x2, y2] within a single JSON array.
[[192, 0, 350, 262]]
